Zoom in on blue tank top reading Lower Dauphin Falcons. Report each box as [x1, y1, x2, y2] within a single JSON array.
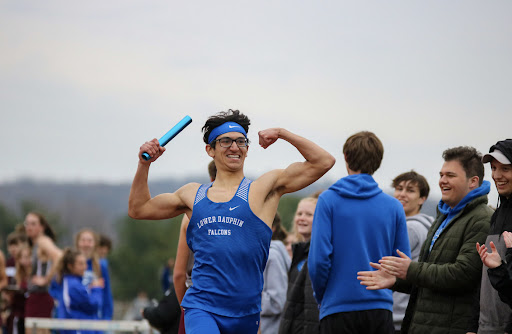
[[182, 178, 272, 317]]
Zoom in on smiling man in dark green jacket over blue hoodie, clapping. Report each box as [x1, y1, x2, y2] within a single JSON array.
[[358, 147, 493, 334]]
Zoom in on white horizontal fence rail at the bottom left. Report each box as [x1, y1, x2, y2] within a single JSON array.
[[25, 318, 151, 333]]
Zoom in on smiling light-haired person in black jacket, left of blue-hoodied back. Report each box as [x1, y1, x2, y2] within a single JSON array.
[[280, 197, 320, 334]]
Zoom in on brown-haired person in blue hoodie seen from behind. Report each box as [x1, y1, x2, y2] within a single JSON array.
[[308, 131, 410, 334]]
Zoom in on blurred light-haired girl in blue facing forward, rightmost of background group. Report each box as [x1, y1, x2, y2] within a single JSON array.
[[75, 228, 114, 320]]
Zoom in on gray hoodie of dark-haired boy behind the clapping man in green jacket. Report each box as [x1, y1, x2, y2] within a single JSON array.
[[393, 213, 434, 330]]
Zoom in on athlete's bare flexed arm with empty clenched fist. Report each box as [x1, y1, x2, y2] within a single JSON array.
[[258, 128, 336, 195]]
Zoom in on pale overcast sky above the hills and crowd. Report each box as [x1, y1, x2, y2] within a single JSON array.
[[0, 0, 512, 204]]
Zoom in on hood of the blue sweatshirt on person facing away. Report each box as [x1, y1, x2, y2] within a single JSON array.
[[329, 174, 382, 199]]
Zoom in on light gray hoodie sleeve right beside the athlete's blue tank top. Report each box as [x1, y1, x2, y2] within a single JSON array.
[[260, 240, 291, 334]]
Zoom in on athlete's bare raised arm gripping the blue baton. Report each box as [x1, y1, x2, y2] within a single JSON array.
[[128, 139, 199, 220]]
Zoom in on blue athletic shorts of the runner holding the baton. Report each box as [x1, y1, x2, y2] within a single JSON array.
[[185, 308, 260, 334]]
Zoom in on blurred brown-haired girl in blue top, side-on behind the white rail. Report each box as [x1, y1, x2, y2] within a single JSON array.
[[57, 248, 103, 334]]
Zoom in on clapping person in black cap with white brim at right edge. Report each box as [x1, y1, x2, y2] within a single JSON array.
[[468, 139, 512, 334]]
